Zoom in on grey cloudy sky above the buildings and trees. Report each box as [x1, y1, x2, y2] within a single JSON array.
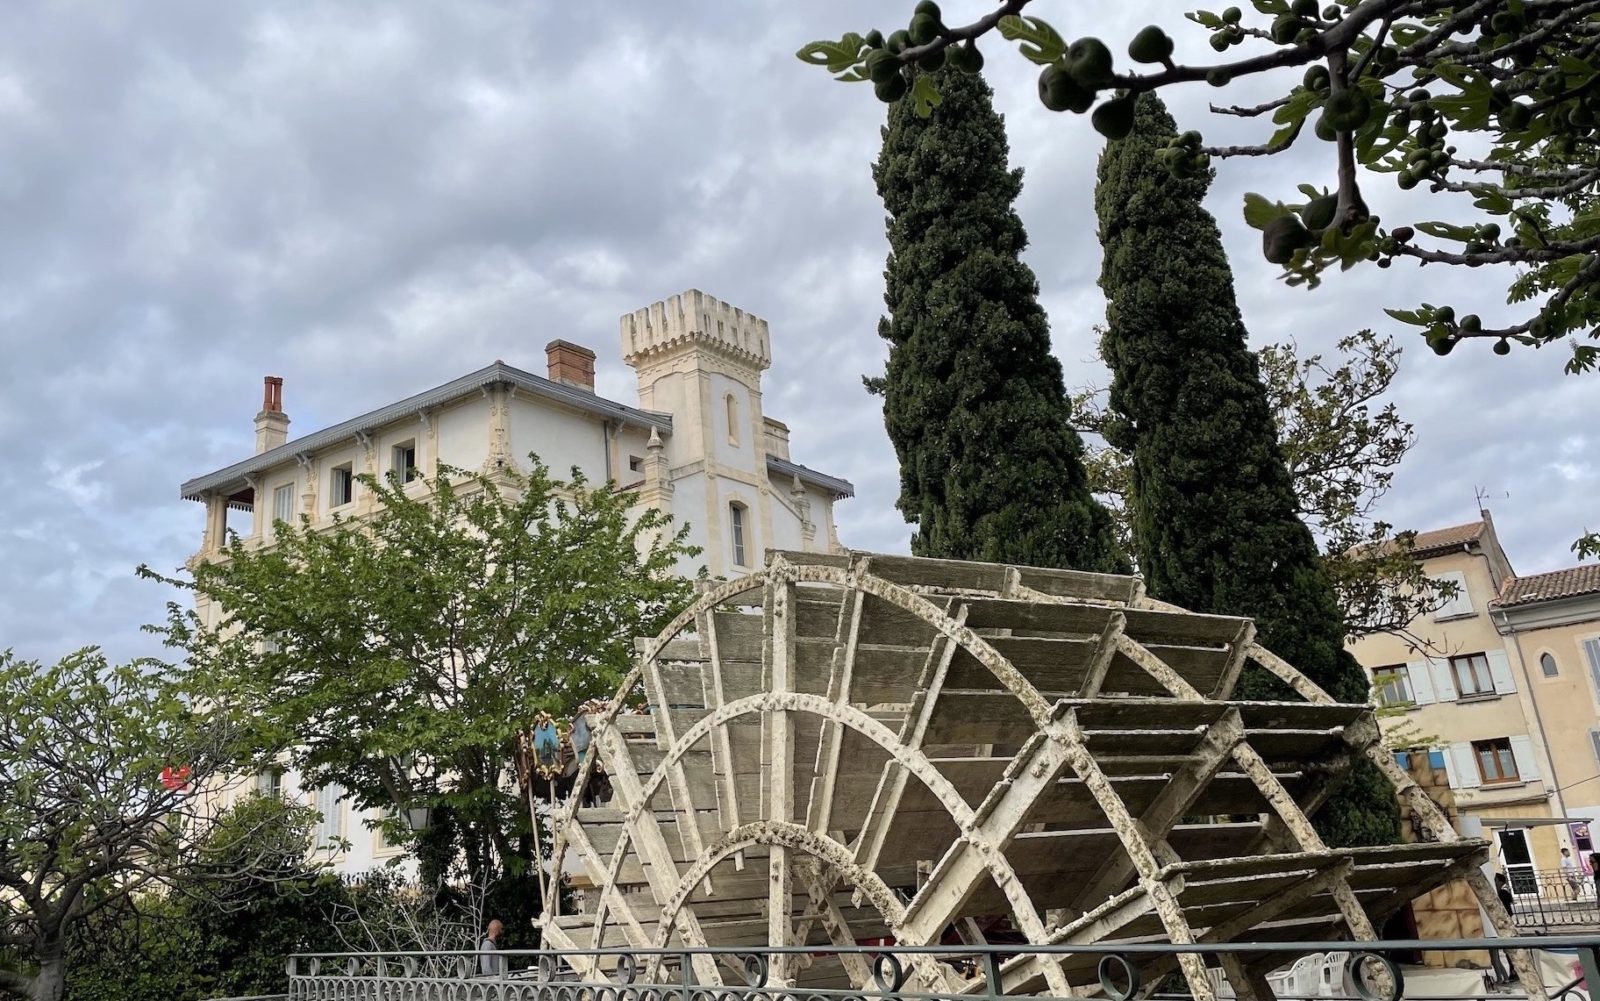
[[0, 0, 1600, 657]]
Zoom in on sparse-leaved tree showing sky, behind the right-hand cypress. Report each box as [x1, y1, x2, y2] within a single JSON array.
[[1074, 329, 1453, 646]]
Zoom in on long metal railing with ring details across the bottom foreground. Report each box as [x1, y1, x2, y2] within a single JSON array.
[[288, 935, 1600, 1001]]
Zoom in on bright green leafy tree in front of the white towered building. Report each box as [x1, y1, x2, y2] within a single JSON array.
[[141, 459, 696, 924]]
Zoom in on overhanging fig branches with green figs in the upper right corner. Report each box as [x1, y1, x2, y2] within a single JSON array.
[[798, 0, 1600, 371]]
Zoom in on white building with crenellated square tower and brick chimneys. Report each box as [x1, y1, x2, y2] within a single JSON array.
[[182, 289, 854, 871]]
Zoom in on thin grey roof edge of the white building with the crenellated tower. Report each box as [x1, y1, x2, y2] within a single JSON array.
[[179, 361, 672, 501]]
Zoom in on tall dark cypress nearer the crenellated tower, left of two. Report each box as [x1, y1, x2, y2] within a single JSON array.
[[867, 70, 1128, 571]]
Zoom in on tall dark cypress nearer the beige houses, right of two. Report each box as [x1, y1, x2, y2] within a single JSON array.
[[1094, 94, 1398, 844]]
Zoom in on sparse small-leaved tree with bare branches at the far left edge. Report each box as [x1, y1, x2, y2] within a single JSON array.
[[0, 649, 301, 1001]]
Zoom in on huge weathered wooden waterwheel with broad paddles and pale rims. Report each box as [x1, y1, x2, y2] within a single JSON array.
[[542, 552, 1544, 1001]]
